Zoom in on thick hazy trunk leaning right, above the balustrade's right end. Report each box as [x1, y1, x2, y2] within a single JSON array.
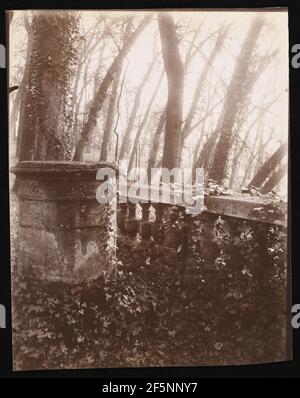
[[208, 17, 264, 183]]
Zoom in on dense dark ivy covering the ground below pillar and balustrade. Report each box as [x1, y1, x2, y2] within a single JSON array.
[[13, 205, 287, 369]]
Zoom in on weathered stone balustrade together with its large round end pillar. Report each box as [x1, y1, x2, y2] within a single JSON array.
[[12, 161, 287, 282]]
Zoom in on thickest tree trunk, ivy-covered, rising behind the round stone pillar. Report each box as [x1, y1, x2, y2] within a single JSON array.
[[19, 11, 78, 160]]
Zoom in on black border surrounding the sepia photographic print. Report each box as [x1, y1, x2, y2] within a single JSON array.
[[0, 0, 300, 380]]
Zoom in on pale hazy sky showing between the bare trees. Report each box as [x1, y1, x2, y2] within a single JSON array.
[[10, 10, 288, 193]]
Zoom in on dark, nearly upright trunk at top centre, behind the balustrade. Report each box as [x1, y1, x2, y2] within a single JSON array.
[[158, 14, 184, 170]]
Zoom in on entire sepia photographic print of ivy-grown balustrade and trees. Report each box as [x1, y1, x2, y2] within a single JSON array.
[[7, 8, 291, 371]]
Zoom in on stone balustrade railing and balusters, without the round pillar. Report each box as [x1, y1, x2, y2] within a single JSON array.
[[117, 195, 287, 238]]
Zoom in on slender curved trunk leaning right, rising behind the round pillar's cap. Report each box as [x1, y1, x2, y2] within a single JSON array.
[[73, 16, 151, 160]]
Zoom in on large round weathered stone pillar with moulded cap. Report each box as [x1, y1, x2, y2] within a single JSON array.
[[12, 161, 116, 283]]
